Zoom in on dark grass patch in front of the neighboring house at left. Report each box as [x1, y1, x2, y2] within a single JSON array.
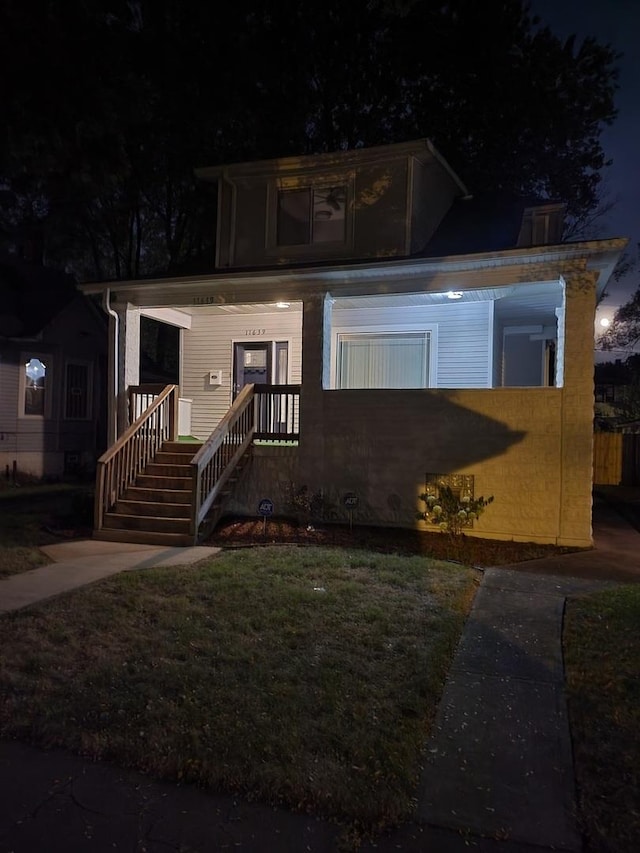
[[0, 484, 94, 578]]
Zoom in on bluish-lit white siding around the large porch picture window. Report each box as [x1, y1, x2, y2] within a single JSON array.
[[332, 301, 493, 388]]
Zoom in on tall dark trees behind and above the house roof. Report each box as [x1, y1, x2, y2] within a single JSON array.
[[0, 0, 617, 278]]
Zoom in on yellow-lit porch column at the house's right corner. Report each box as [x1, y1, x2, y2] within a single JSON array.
[[558, 269, 597, 546]]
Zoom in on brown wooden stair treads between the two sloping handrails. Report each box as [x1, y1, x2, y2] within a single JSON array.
[[94, 441, 202, 546]]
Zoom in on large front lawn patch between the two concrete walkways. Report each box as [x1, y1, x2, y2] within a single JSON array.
[[0, 547, 477, 830]]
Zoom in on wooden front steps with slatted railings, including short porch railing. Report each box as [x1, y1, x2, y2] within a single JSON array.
[[94, 385, 300, 546]]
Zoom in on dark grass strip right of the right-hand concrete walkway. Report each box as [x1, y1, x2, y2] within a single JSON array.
[[564, 585, 640, 853]]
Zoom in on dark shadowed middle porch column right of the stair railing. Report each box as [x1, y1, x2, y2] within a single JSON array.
[[296, 293, 332, 492]]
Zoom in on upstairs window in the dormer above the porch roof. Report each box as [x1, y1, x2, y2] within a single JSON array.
[[277, 186, 347, 246]]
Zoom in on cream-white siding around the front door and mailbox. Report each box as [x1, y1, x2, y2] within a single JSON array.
[[180, 303, 302, 438]]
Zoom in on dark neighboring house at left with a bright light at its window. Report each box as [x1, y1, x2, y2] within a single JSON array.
[[0, 256, 107, 478]]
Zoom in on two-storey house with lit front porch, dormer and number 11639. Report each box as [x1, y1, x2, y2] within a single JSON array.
[[83, 139, 626, 546]]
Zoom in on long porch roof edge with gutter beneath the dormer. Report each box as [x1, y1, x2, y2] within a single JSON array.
[[80, 238, 628, 307]]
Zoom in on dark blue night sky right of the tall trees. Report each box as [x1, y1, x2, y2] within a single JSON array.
[[531, 0, 640, 328]]
